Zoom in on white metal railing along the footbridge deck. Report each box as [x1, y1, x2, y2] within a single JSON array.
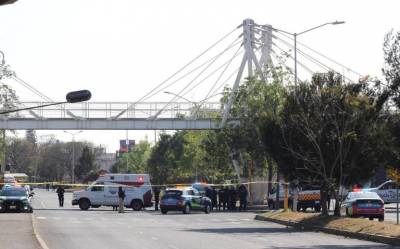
[[5, 102, 222, 119]]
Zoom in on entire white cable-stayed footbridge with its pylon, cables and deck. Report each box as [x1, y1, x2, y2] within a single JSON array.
[[0, 19, 360, 130]]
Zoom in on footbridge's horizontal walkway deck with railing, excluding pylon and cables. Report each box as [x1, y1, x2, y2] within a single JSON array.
[[0, 102, 238, 130]]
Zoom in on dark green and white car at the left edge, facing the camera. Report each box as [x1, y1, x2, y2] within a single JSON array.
[[0, 187, 33, 213]]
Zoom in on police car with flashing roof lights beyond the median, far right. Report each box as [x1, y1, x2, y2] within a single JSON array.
[[342, 192, 385, 221]]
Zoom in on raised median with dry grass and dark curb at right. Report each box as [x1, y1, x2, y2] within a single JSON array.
[[255, 211, 400, 246]]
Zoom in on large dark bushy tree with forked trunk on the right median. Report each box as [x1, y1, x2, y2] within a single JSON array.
[[282, 72, 388, 215]]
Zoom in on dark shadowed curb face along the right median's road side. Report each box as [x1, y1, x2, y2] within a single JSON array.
[[254, 215, 400, 246]]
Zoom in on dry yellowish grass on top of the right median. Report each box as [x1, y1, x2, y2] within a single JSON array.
[[263, 211, 400, 238]]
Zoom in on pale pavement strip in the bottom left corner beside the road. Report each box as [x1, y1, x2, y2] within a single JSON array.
[[0, 213, 41, 249]]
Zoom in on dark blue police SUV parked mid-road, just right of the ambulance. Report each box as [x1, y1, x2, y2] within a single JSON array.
[[160, 188, 211, 214]]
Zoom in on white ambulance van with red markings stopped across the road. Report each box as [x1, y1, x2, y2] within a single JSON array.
[[72, 174, 153, 211]]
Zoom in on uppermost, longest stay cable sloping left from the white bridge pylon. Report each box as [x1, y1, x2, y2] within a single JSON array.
[[113, 26, 240, 119]]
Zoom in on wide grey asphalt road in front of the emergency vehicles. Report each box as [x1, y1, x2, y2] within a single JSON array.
[[30, 190, 393, 249]]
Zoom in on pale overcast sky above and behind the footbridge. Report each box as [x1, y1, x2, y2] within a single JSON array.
[[0, 0, 400, 152]]
